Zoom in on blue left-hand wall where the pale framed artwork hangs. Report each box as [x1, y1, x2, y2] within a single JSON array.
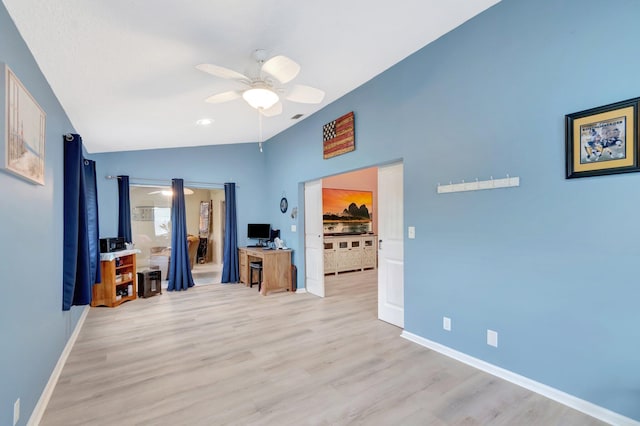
[[0, 5, 82, 425]]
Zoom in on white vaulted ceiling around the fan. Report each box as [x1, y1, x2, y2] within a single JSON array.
[[3, 0, 499, 152]]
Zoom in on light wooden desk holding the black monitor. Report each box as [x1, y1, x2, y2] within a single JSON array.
[[238, 247, 291, 296]]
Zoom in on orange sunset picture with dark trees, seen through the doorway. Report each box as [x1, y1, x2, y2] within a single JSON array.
[[322, 188, 373, 234]]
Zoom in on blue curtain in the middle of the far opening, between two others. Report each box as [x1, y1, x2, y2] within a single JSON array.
[[167, 179, 194, 291]]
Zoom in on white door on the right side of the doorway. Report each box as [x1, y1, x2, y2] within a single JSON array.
[[378, 163, 404, 328]]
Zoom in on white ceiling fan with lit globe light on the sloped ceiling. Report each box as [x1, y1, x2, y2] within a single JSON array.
[[196, 49, 324, 117]]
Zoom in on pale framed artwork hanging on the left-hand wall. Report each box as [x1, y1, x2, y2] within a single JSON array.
[[2, 65, 46, 185]]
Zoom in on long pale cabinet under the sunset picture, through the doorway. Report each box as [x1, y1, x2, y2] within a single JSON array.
[[324, 234, 378, 274]]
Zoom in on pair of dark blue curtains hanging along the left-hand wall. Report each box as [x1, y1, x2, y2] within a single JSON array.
[[62, 134, 100, 311]]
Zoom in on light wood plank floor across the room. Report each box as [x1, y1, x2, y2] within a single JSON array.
[[41, 271, 602, 426]]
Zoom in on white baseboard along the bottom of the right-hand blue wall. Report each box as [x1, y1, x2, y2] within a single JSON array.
[[400, 331, 640, 426]]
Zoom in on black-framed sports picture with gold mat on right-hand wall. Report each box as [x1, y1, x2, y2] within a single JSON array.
[[565, 98, 640, 179]]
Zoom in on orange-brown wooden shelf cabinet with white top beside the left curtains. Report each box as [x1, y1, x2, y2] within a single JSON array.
[[91, 250, 140, 308]]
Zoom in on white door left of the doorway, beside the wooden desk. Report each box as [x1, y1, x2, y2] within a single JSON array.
[[304, 180, 324, 297]]
